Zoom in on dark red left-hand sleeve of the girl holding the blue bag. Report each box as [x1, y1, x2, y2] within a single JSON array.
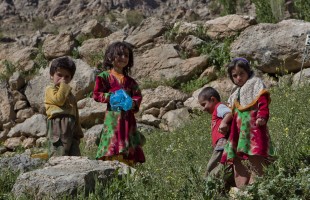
[[93, 76, 111, 103]]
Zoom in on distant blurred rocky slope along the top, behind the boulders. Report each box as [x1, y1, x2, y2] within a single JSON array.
[[0, 0, 254, 38]]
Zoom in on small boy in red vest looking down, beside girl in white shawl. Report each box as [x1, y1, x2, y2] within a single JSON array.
[[198, 87, 233, 177]]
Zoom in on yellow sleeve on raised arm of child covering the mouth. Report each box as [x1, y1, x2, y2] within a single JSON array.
[[45, 83, 71, 106]]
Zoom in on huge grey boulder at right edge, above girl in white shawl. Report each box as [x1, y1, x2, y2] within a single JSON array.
[[231, 19, 310, 74]]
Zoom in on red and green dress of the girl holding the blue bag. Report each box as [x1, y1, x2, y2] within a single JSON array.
[[93, 71, 145, 164]]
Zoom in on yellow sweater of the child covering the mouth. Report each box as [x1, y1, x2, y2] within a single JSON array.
[[44, 83, 79, 119]]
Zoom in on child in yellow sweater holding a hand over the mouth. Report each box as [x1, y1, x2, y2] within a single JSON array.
[[44, 56, 83, 157]]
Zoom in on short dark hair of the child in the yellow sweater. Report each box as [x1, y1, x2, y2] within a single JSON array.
[[50, 56, 76, 78]]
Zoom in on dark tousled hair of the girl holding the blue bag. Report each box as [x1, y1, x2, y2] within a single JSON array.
[[102, 41, 133, 75]]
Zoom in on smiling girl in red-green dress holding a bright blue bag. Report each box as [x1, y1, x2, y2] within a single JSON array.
[[93, 42, 145, 166]]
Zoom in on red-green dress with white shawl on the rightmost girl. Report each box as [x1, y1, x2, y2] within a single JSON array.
[[222, 77, 273, 162]]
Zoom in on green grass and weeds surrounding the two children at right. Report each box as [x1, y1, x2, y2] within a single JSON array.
[[0, 86, 310, 200]]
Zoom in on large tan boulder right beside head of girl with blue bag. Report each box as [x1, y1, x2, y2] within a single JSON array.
[[132, 44, 208, 82]]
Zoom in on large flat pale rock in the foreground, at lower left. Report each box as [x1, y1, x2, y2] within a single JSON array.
[[12, 156, 135, 199]]
